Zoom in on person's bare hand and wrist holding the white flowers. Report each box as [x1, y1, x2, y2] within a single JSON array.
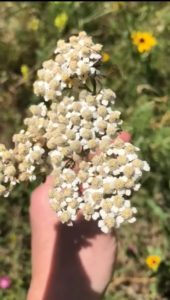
[[27, 133, 130, 300]]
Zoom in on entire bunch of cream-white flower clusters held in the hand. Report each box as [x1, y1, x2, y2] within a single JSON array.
[[0, 32, 149, 233]]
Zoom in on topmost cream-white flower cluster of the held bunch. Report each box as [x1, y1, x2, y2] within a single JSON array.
[[34, 32, 102, 101]]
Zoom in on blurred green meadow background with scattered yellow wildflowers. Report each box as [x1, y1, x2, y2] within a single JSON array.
[[0, 1, 170, 300]]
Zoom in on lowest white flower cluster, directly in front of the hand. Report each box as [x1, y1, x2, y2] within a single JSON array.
[[49, 138, 149, 233]]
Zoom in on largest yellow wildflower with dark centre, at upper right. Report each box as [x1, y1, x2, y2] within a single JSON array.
[[131, 31, 157, 53]]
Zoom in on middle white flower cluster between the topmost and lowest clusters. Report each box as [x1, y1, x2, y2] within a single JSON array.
[[44, 89, 119, 156]]
